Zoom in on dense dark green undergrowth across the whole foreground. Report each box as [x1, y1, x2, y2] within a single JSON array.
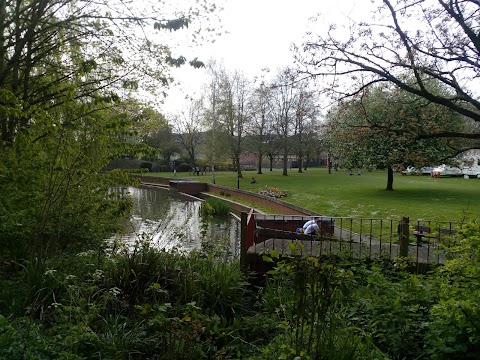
[[0, 218, 480, 359]]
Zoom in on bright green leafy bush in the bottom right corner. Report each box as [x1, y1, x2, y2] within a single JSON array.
[[427, 221, 480, 359]]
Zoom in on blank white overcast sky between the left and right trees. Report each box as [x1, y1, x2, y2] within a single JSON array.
[[162, 0, 371, 114]]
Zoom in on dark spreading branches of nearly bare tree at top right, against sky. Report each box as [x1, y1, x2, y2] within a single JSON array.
[[296, 0, 480, 139]]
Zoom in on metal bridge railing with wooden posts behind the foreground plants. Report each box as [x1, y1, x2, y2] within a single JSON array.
[[241, 211, 455, 268]]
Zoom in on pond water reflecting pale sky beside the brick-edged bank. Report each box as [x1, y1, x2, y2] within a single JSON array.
[[112, 187, 240, 256]]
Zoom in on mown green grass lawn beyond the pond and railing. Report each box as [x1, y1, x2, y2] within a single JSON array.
[[149, 168, 480, 221]]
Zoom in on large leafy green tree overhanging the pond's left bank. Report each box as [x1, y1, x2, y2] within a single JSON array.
[[0, 0, 219, 258]]
